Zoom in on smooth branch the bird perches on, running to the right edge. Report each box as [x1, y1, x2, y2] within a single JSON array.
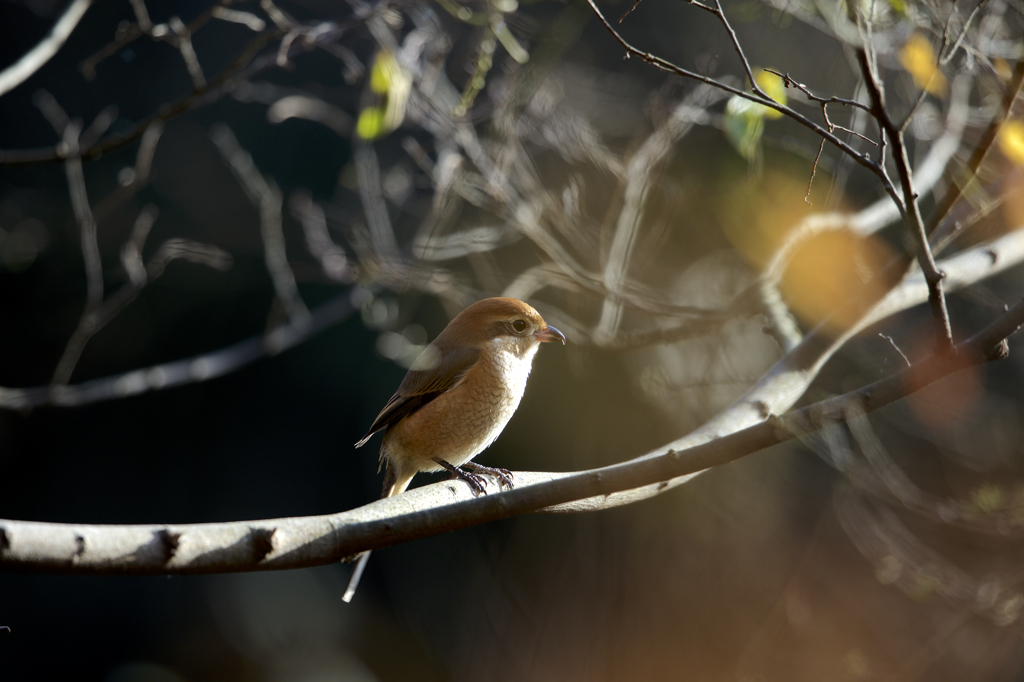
[[0, 272, 1024, 574]]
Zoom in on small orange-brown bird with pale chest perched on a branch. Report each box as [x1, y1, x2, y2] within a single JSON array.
[[342, 298, 565, 602]]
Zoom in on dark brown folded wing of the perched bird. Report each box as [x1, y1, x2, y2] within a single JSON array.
[[355, 346, 480, 447]]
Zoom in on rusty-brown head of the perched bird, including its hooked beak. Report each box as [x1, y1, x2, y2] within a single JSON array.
[[435, 298, 565, 354]]
